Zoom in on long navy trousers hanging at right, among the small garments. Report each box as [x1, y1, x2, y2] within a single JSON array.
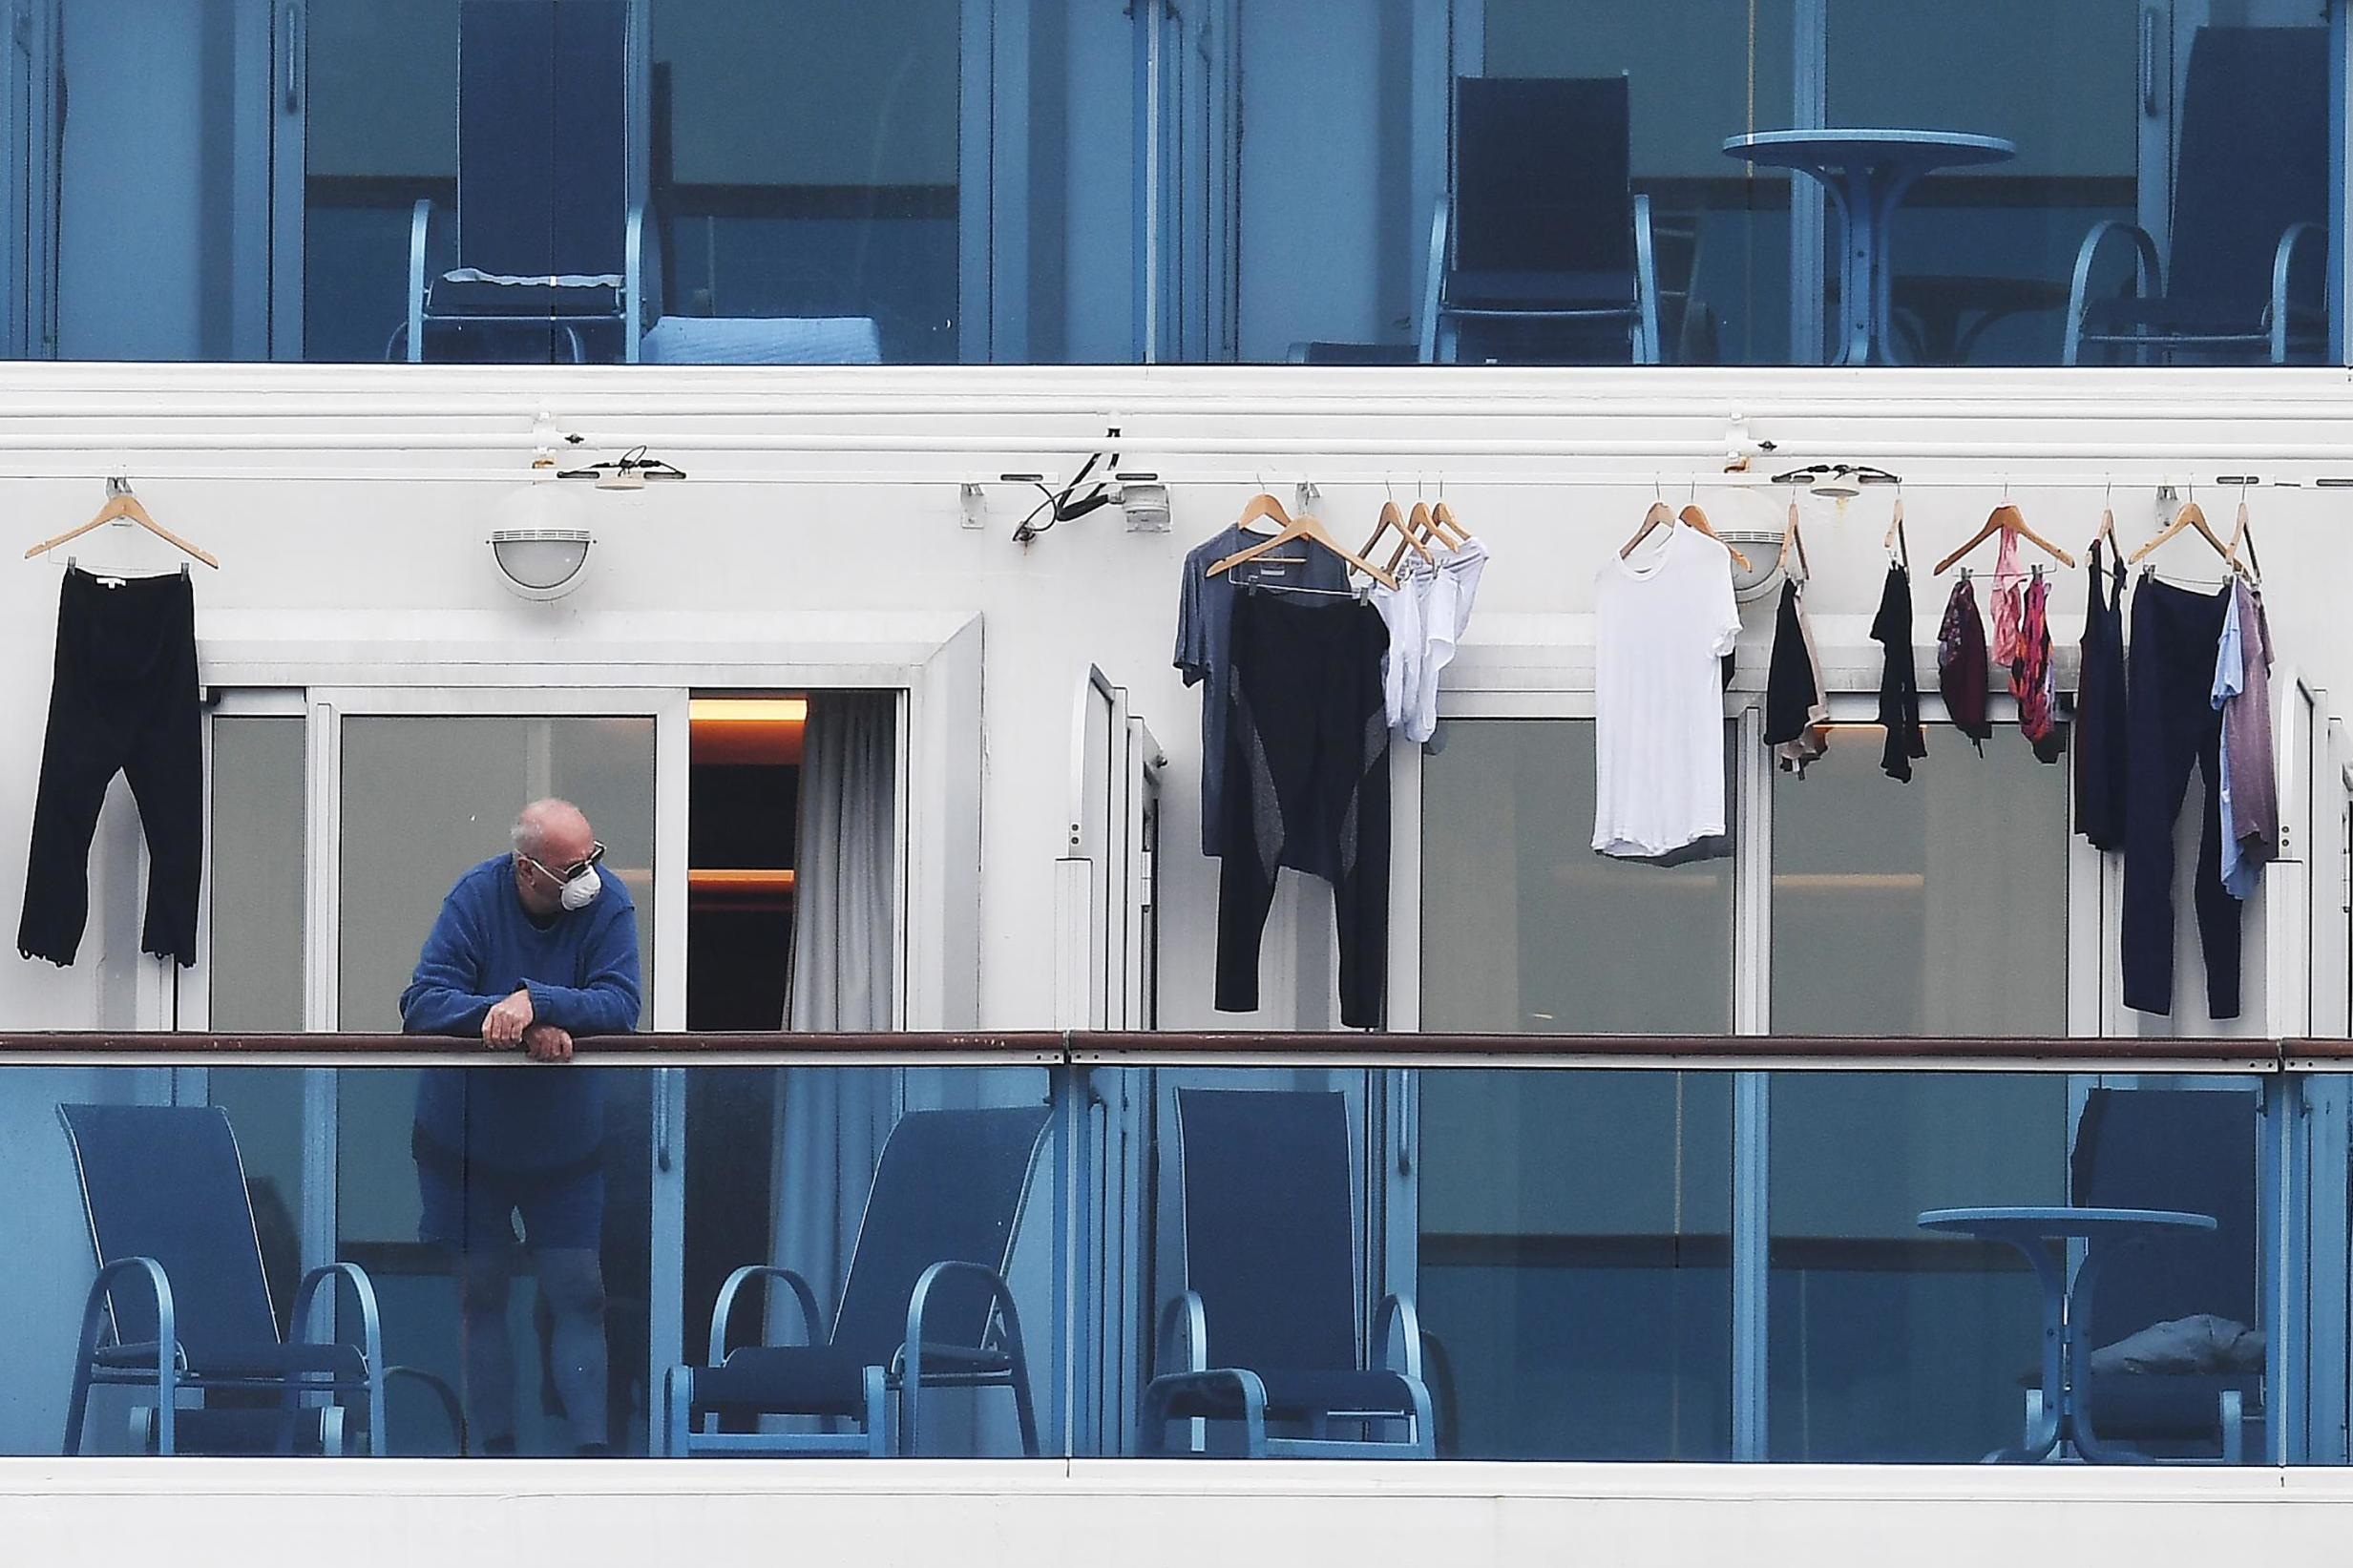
[[2125, 578, 2240, 1018]]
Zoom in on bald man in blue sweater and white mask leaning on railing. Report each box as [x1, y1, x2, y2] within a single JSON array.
[[400, 800, 640, 1455]]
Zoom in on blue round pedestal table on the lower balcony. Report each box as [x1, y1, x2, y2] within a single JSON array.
[[1920, 1206, 2216, 1465]]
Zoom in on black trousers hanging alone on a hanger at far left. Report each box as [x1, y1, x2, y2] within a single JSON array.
[[16, 569, 204, 966]]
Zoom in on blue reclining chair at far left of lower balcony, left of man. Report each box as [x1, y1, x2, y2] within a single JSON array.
[[56, 1105, 384, 1455]]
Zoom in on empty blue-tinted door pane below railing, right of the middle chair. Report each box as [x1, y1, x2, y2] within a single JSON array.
[[1414, 1070, 1732, 1460]]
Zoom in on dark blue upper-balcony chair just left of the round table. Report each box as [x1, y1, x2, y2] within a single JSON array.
[[1421, 75, 1659, 365]]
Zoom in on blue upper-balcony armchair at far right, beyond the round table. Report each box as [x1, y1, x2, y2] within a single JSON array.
[[2061, 29, 2329, 365]]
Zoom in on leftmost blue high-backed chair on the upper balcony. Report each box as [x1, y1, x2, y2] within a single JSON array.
[[395, 0, 644, 365]]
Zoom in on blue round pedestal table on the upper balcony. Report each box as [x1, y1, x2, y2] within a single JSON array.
[[1725, 129, 2019, 365]]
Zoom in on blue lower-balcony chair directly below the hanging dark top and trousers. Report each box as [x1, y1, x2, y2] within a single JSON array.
[[1139, 1088, 1436, 1457]]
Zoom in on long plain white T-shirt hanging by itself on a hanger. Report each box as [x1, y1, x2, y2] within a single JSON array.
[[1593, 524, 1741, 856]]
